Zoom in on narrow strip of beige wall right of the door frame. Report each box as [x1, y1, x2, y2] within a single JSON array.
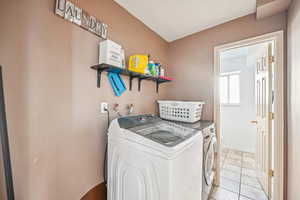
[[287, 0, 300, 200]]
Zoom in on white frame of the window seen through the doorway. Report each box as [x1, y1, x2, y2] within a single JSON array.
[[219, 71, 241, 106]]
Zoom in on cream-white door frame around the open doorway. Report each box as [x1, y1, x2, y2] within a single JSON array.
[[214, 30, 286, 200]]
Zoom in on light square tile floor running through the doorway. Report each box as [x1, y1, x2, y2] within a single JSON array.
[[209, 149, 268, 200]]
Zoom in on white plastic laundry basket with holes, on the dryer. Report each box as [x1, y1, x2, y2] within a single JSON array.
[[157, 101, 204, 123]]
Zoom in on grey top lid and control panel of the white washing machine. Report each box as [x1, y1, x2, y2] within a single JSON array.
[[119, 115, 198, 147]]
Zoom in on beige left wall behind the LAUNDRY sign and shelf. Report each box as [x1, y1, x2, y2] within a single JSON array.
[[0, 0, 168, 200]]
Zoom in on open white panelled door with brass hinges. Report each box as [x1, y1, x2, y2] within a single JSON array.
[[254, 43, 274, 198]]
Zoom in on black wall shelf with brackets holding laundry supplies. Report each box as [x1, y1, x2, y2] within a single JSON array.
[[91, 64, 171, 93]]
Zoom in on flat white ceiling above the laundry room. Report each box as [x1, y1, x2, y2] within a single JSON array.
[[114, 0, 256, 42]]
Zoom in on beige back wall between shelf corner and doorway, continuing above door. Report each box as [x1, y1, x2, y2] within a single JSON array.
[[167, 13, 286, 119]]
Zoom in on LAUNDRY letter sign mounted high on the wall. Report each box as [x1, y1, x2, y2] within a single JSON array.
[[55, 0, 108, 39]]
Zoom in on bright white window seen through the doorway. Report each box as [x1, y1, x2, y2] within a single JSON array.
[[220, 71, 240, 105]]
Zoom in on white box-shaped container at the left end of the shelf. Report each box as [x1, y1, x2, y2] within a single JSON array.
[[99, 40, 122, 67]]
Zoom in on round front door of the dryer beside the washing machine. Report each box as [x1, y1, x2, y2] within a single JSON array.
[[203, 136, 217, 186]]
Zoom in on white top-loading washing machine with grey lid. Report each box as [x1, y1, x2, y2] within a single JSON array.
[[108, 115, 203, 200]]
